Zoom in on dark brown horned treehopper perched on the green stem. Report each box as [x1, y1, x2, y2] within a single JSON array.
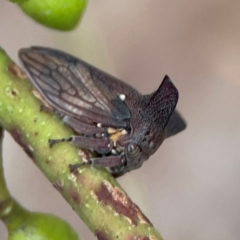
[[19, 47, 186, 176]]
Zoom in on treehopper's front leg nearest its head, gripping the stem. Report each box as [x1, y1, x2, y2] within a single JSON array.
[[69, 155, 126, 172]]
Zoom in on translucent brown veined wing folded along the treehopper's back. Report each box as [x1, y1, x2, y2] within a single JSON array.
[[19, 47, 130, 128]]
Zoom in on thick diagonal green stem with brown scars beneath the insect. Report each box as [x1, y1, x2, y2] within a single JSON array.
[[0, 47, 162, 240]]
